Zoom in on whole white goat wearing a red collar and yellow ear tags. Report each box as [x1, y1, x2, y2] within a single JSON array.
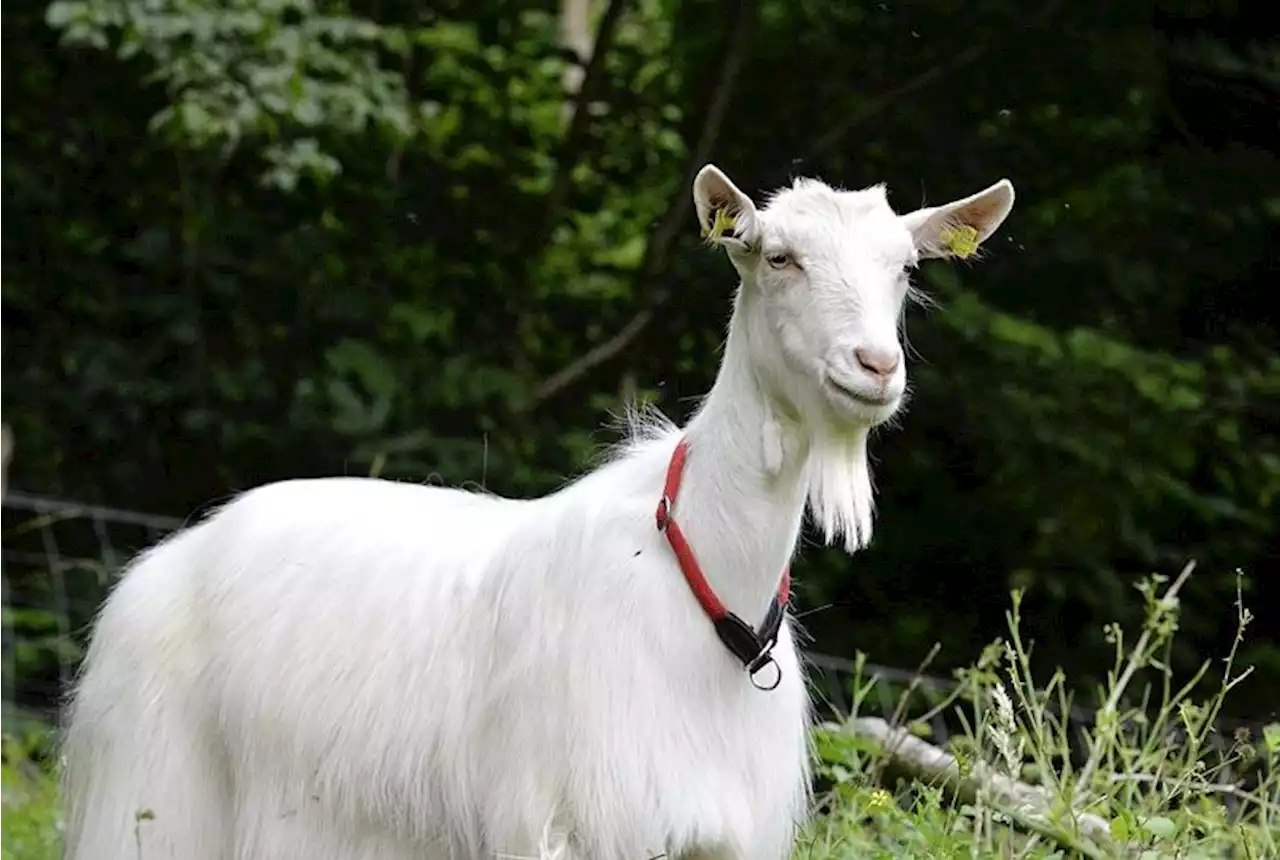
[[64, 165, 1014, 860]]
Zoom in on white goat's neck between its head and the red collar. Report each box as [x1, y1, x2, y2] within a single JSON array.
[[675, 294, 809, 626]]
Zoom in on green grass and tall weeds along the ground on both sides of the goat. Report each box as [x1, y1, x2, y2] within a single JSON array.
[[0, 566, 1280, 860]]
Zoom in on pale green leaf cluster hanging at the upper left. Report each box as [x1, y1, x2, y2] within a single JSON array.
[[45, 0, 419, 191]]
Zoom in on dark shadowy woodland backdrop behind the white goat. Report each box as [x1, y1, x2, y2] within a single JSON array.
[[0, 0, 1280, 718]]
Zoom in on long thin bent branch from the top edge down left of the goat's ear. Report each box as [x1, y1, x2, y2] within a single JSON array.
[[526, 0, 758, 408]]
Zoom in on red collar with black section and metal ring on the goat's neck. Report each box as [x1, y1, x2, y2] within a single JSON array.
[[657, 439, 791, 690]]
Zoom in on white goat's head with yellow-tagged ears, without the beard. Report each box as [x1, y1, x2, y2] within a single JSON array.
[[694, 165, 1014, 427]]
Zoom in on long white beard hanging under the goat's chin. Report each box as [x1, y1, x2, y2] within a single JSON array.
[[808, 420, 874, 553]]
